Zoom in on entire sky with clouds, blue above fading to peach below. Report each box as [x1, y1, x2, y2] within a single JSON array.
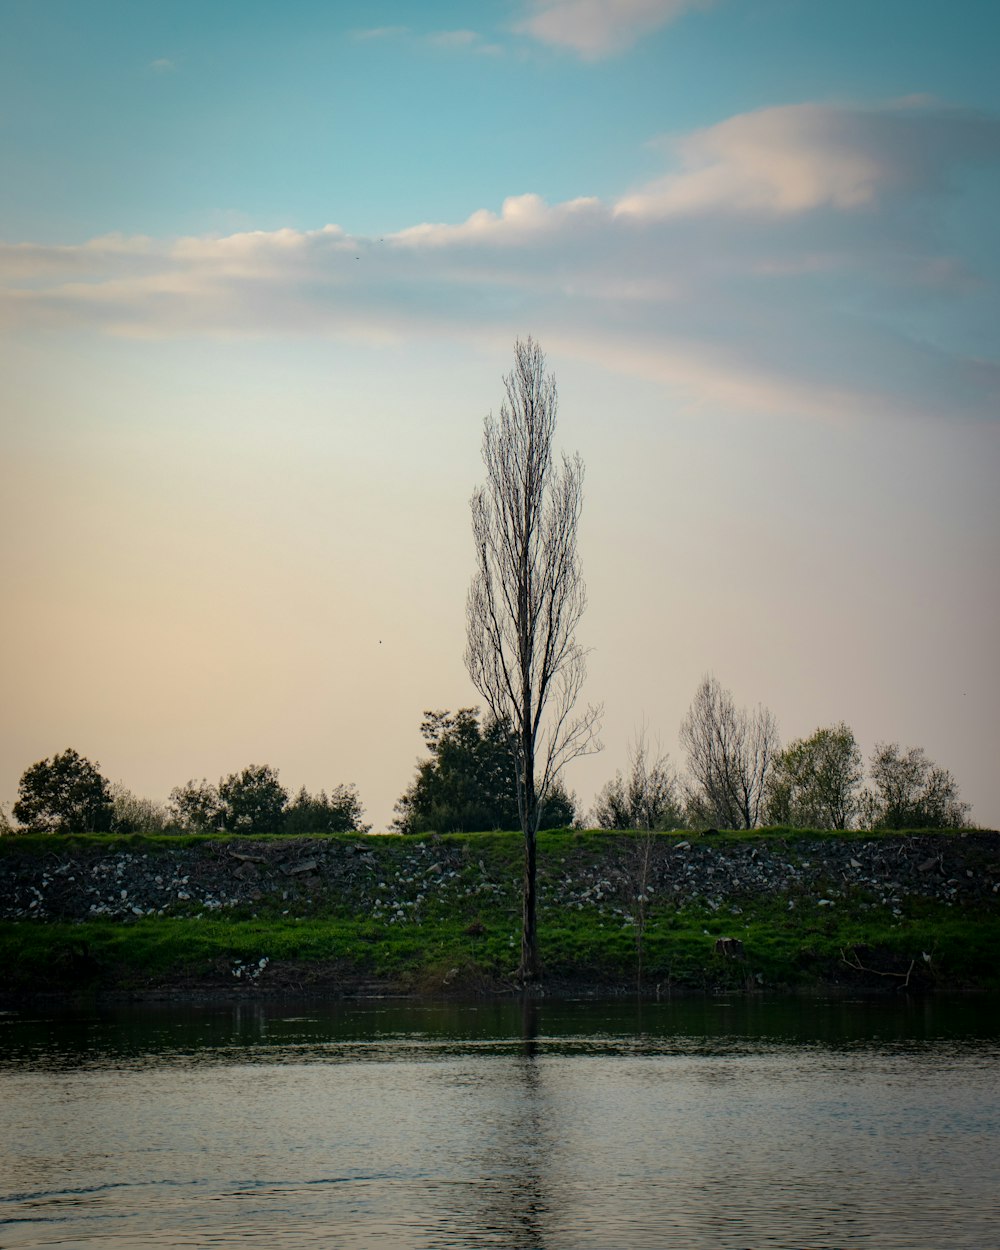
[[0, 0, 1000, 830]]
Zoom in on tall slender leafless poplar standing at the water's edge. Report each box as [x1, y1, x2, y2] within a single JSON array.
[[465, 338, 600, 984]]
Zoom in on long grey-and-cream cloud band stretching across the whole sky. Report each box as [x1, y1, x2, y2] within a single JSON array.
[[0, 103, 1000, 416]]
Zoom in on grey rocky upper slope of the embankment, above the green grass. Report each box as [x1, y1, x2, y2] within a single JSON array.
[[0, 831, 1000, 925]]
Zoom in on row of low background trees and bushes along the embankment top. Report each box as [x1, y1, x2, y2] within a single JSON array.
[[3, 695, 969, 835]]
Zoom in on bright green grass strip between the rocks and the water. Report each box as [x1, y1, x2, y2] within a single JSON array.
[[0, 900, 1000, 991]]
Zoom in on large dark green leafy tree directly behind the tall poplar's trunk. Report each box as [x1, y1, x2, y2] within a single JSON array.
[[394, 708, 575, 834]]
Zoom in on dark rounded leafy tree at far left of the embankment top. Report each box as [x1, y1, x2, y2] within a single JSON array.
[[13, 748, 114, 834]]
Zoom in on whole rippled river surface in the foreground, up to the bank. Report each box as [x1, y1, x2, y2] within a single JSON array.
[[0, 999, 1000, 1250]]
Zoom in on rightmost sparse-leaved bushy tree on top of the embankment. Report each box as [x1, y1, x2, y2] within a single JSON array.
[[861, 743, 969, 829]]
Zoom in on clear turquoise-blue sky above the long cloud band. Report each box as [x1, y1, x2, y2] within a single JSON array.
[[7, 0, 1000, 243]]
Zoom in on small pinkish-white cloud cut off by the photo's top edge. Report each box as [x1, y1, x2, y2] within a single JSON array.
[[516, 0, 709, 60]]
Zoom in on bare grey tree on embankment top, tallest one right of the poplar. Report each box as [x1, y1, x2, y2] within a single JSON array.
[[680, 676, 781, 829]]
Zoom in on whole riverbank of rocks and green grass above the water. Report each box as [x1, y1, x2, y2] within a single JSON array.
[[0, 830, 1000, 998]]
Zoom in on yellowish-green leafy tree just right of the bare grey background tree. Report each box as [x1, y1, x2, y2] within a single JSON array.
[[765, 721, 863, 829]]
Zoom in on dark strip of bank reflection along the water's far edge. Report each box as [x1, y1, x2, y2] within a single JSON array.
[[0, 998, 1000, 1070]]
